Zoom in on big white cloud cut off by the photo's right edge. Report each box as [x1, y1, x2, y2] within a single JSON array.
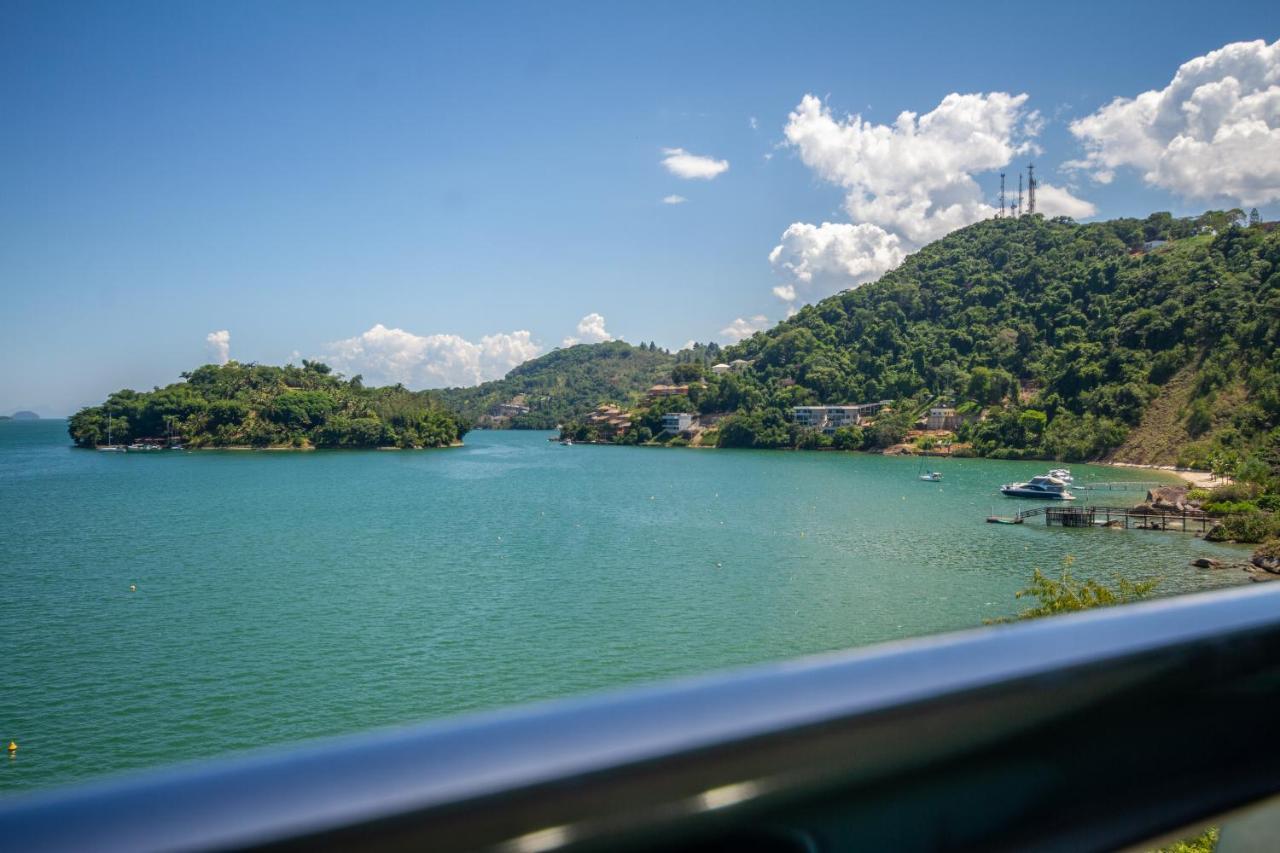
[[1068, 40, 1280, 205]]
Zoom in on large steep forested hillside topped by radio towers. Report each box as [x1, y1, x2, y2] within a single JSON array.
[[690, 211, 1280, 465]]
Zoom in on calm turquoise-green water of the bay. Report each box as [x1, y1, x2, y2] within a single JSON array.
[[0, 421, 1244, 792]]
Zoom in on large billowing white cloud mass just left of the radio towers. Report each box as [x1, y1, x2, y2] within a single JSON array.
[[769, 92, 1059, 307]]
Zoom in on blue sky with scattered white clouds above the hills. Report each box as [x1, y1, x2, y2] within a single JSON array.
[[0, 0, 1280, 416]]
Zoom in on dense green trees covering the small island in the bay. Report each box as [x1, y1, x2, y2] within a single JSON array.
[[68, 361, 467, 448]]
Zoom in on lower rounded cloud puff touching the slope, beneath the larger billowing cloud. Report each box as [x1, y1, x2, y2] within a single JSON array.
[[769, 222, 906, 302]]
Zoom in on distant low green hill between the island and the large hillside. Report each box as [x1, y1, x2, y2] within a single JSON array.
[[438, 341, 691, 429]]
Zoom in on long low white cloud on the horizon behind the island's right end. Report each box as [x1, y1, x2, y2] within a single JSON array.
[[328, 323, 541, 388]]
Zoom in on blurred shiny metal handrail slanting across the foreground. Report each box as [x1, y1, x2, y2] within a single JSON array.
[[0, 584, 1280, 850]]
